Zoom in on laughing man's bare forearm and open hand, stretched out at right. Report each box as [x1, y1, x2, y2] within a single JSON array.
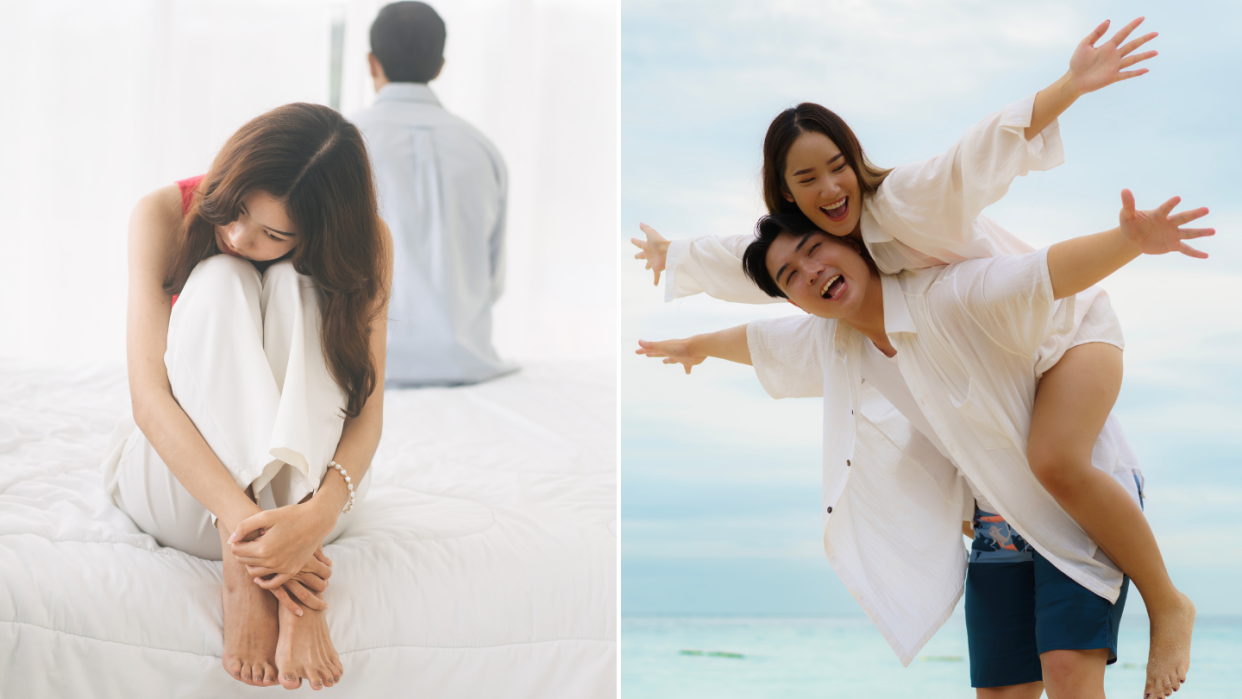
[[1048, 189, 1216, 299]]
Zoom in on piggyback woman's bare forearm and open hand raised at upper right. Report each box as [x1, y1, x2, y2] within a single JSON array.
[[1025, 17, 1156, 140]]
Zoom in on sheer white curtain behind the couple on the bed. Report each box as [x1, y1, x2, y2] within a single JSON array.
[[0, 0, 616, 361]]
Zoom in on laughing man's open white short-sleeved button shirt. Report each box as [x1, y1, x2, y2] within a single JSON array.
[[746, 250, 1141, 664]]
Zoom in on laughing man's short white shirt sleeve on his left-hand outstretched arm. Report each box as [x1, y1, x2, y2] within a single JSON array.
[[746, 315, 828, 399]]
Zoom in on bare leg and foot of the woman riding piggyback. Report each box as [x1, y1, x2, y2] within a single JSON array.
[[1027, 343, 1195, 697]]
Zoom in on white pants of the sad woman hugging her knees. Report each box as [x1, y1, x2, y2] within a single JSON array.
[[103, 255, 370, 560]]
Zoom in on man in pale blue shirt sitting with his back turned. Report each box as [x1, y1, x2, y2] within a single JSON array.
[[353, 2, 514, 386]]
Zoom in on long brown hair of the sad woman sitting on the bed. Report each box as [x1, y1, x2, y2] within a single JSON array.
[[164, 103, 388, 417]]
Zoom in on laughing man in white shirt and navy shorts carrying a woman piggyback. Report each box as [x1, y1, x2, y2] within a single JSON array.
[[638, 190, 1213, 697]]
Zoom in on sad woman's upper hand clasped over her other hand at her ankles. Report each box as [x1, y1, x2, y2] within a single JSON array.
[[229, 500, 335, 589]]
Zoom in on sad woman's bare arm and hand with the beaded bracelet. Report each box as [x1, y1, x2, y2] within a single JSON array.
[[229, 221, 392, 590]]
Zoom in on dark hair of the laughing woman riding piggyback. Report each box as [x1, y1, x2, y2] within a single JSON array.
[[763, 102, 892, 214]]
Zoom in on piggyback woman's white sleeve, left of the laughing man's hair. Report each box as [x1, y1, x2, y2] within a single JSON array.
[[664, 235, 785, 303]]
